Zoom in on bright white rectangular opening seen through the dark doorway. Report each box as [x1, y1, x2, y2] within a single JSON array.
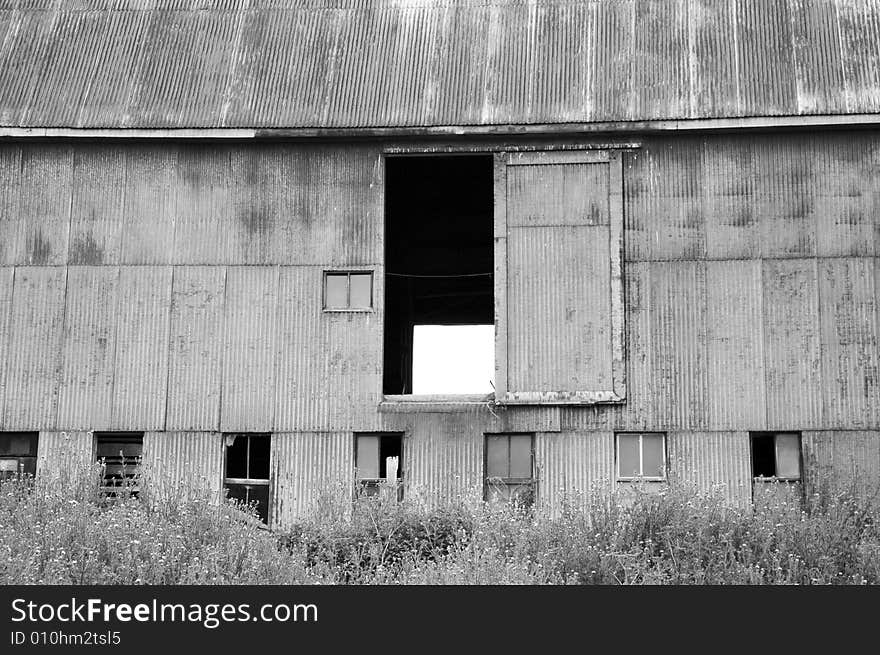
[[413, 325, 495, 395]]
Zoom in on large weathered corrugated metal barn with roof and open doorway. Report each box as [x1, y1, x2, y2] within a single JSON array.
[[0, 0, 880, 528]]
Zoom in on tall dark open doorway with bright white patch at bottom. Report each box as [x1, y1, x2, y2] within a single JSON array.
[[383, 155, 495, 395]]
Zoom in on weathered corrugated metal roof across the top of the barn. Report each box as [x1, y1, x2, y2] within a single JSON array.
[[0, 0, 880, 128]]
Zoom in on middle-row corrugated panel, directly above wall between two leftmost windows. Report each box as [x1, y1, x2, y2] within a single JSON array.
[[57, 266, 119, 430]]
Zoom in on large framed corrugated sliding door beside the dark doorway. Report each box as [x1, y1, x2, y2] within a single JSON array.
[[495, 151, 626, 404]]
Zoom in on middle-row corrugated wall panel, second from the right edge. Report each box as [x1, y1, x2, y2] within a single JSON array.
[[762, 259, 822, 430]]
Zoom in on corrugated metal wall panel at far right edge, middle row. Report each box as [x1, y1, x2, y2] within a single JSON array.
[[819, 258, 880, 428]]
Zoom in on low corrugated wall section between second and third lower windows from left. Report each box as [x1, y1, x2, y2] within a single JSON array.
[[143, 432, 223, 499]]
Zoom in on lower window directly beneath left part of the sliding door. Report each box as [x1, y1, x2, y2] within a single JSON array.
[[484, 434, 536, 505]]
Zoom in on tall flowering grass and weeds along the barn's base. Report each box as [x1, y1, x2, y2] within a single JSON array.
[[0, 468, 880, 585]]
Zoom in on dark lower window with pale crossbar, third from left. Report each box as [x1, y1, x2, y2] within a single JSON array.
[[223, 433, 271, 523]]
